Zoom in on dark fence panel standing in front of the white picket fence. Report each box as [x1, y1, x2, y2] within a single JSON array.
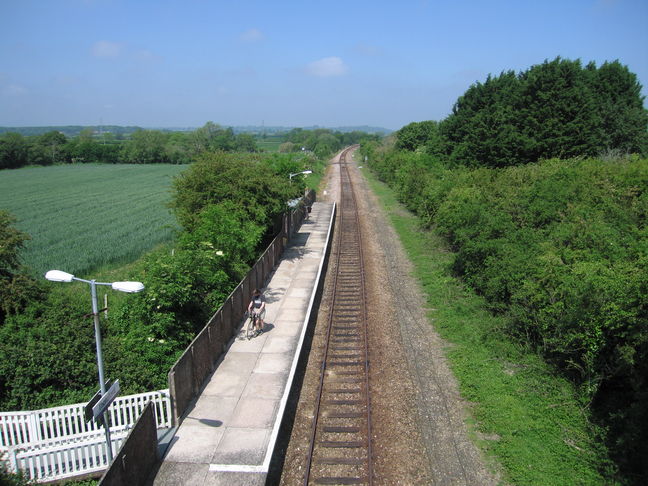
[[99, 402, 158, 486]]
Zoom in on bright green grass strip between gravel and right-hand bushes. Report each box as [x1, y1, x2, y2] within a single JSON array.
[[365, 171, 616, 486]]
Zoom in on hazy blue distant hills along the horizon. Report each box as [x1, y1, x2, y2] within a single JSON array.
[[0, 125, 392, 138]]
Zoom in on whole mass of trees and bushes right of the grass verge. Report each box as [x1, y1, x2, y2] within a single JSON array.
[[370, 58, 648, 482]]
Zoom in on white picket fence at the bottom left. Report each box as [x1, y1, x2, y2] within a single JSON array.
[[0, 389, 172, 481]]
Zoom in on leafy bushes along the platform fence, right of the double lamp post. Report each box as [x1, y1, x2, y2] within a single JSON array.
[[99, 153, 301, 392]]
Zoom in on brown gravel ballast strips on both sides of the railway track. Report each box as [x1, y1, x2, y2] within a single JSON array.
[[280, 149, 499, 486]]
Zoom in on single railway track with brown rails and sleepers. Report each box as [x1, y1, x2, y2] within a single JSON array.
[[304, 148, 373, 486]]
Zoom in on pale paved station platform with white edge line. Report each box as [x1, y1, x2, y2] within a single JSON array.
[[149, 202, 334, 486]]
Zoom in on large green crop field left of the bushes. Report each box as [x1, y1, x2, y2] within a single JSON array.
[[0, 164, 187, 275]]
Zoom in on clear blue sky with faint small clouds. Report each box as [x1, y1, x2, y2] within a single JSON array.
[[0, 0, 648, 129]]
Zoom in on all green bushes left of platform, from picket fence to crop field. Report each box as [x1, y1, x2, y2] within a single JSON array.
[[0, 153, 310, 410]]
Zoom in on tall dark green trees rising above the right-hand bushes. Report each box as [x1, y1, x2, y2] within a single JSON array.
[[396, 57, 648, 167]]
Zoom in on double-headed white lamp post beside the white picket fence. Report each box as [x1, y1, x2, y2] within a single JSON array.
[[45, 270, 144, 464]]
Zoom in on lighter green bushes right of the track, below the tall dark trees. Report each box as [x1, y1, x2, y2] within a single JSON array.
[[370, 146, 648, 480]]
